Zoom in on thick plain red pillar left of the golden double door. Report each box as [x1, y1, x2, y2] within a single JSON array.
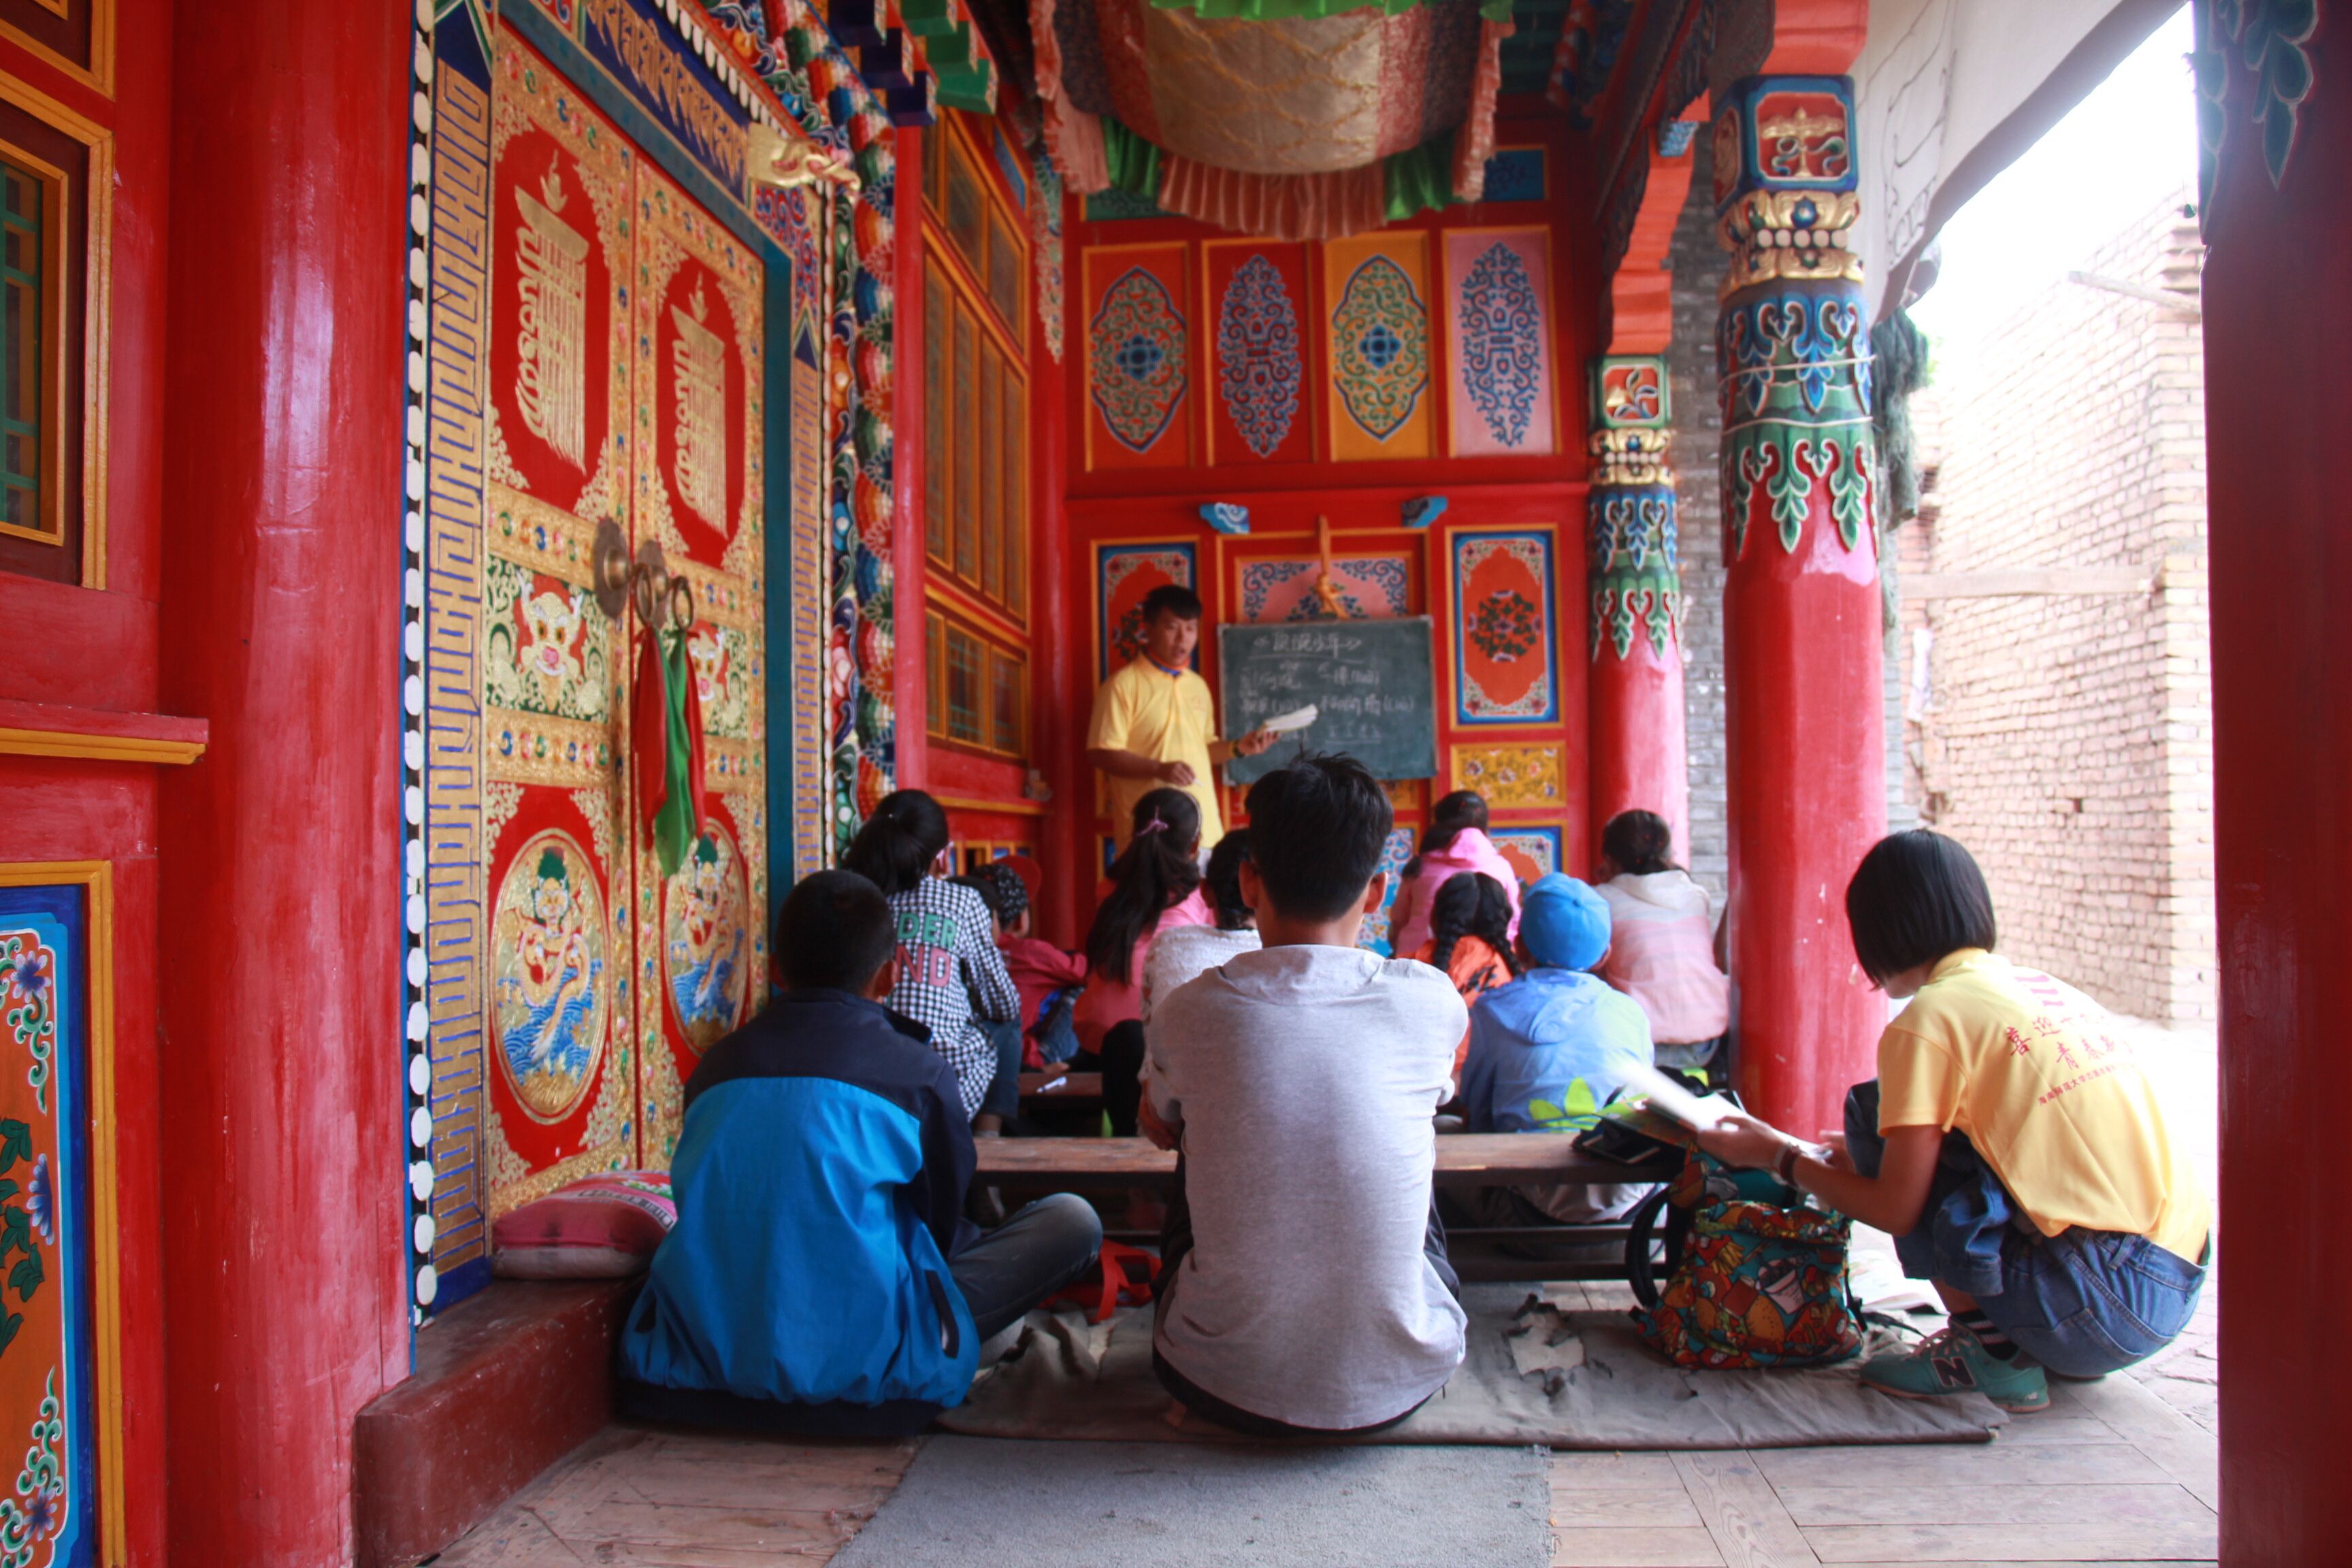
[[160, 0, 414, 1568]]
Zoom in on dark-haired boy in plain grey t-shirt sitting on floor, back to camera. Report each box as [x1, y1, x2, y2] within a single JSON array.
[[1141, 757, 1468, 1434]]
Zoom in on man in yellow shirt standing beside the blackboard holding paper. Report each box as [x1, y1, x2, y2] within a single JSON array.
[[1087, 583, 1275, 853]]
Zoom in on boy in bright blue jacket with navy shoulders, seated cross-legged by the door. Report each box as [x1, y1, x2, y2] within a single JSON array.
[[616, 870, 1103, 1437]]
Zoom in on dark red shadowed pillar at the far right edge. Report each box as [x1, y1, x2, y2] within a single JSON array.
[[2204, 14, 2352, 1568]]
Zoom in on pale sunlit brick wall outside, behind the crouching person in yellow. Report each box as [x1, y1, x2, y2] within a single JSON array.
[[1900, 195, 2216, 1018]]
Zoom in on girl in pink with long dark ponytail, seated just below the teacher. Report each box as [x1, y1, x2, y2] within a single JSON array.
[[1070, 790, 1216, 1138]]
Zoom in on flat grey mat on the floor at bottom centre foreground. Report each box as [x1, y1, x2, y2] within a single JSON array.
[[832, 1437, 1552, 1568]]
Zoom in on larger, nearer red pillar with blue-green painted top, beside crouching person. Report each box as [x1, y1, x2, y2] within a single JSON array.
[[1714, 76, 1886, 1135]]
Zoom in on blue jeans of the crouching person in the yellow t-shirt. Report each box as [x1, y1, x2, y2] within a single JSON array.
[[1846, 1081, 2204, 1377]]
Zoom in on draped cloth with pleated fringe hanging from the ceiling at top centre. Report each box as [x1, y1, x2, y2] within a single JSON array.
[[1030, 0, 1512, 240]]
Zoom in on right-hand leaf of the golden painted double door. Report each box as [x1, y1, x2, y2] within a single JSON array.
[[633, 162, 769, 1164]]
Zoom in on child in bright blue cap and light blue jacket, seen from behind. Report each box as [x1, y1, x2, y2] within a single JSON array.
[[1460, 872, 1656, 1225]]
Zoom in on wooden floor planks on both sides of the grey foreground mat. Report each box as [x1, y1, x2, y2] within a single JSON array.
[[435, 1377, 2218, 1568]]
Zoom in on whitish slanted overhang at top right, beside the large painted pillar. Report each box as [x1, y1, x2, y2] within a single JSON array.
[[1853, 0, 2187, 322]]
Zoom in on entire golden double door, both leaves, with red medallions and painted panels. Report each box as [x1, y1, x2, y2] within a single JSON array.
[[472, 35, 767, 1222]]
